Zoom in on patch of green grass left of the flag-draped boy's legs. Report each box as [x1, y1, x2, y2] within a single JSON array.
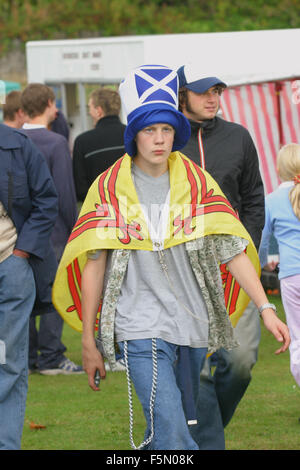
[[22, 325, 144, 450]]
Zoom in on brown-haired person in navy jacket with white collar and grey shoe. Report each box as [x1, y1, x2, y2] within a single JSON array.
[[21, 83, 83, 375]]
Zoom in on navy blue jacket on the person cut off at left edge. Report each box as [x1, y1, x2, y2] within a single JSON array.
[[0, 125, 58, 313]]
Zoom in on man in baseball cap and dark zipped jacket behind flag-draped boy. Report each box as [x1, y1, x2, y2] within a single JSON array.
[[178, 65, 265, 449]]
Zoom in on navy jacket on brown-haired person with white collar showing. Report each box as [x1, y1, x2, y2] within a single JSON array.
[[22, 127, 78, 260]]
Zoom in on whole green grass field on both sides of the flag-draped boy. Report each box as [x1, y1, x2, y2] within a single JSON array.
[[22, 297, 300, 450]]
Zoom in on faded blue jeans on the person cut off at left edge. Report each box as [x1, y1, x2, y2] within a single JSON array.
[[0, 255, 35, 450]]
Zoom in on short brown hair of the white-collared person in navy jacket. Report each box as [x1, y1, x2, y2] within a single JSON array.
[[21, 83, 55, 118]]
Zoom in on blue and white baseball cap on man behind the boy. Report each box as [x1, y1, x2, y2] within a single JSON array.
[[177, 65, 227, 93]]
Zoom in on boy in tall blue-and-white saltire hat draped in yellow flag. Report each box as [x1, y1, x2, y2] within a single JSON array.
[[53, 65, 289, 450]]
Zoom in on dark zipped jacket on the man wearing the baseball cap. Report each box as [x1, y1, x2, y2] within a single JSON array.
[[180, 117, 265, 249]]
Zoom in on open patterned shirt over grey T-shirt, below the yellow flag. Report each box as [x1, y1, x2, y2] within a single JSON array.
[[96, 235, 248, 370]]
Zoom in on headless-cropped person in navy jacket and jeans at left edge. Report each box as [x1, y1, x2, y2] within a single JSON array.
[[0, 124, 58, 450]]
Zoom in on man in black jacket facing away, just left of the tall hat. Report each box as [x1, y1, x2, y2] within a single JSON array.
[[73, 87, 125, 201]]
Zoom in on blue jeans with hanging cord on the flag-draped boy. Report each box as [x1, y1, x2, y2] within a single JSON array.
[[119, 339, 207, 450]]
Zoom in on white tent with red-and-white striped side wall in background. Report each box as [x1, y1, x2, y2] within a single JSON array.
[[26, 29, 300, 192]]
